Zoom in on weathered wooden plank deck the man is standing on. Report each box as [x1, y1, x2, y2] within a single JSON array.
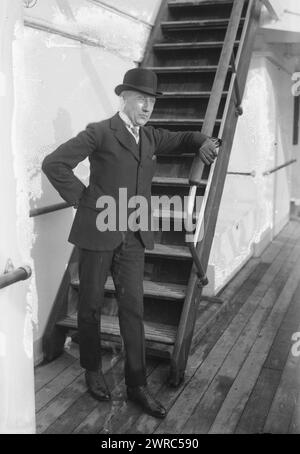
[[36, 220, 300, 434]]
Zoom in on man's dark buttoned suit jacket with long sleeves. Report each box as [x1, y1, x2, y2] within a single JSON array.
[[42, 114, 207, 250]]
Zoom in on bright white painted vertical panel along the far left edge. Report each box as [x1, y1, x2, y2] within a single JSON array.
[[0, 0, 36, 434]]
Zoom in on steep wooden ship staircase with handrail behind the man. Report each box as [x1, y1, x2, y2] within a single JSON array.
[[44, 0, 261, 386]]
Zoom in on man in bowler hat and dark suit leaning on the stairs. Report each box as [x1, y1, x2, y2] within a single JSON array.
[[42, 68, 216, 418]]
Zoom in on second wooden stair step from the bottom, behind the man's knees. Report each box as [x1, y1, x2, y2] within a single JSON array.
[[71, 276, 186, 301]]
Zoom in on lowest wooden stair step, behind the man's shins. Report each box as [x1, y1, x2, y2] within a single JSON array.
[[57, 313, 177, 345]]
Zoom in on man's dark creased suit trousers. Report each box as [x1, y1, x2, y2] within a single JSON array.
[[78, 231, 146, 386]]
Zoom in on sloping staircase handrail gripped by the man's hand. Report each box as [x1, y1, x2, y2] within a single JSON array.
[[186, 0, 253, 286]]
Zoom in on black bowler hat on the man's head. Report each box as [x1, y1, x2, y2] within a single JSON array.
[[115, 68, 162, 96]]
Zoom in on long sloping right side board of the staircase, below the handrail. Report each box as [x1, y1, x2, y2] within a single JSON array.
[[169, 0, 262, 386]]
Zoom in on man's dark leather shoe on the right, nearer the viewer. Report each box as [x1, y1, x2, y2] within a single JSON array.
[[127, 386, 167, 418]]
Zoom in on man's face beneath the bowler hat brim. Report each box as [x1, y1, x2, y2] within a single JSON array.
[[123, 90, 155, 126]]
